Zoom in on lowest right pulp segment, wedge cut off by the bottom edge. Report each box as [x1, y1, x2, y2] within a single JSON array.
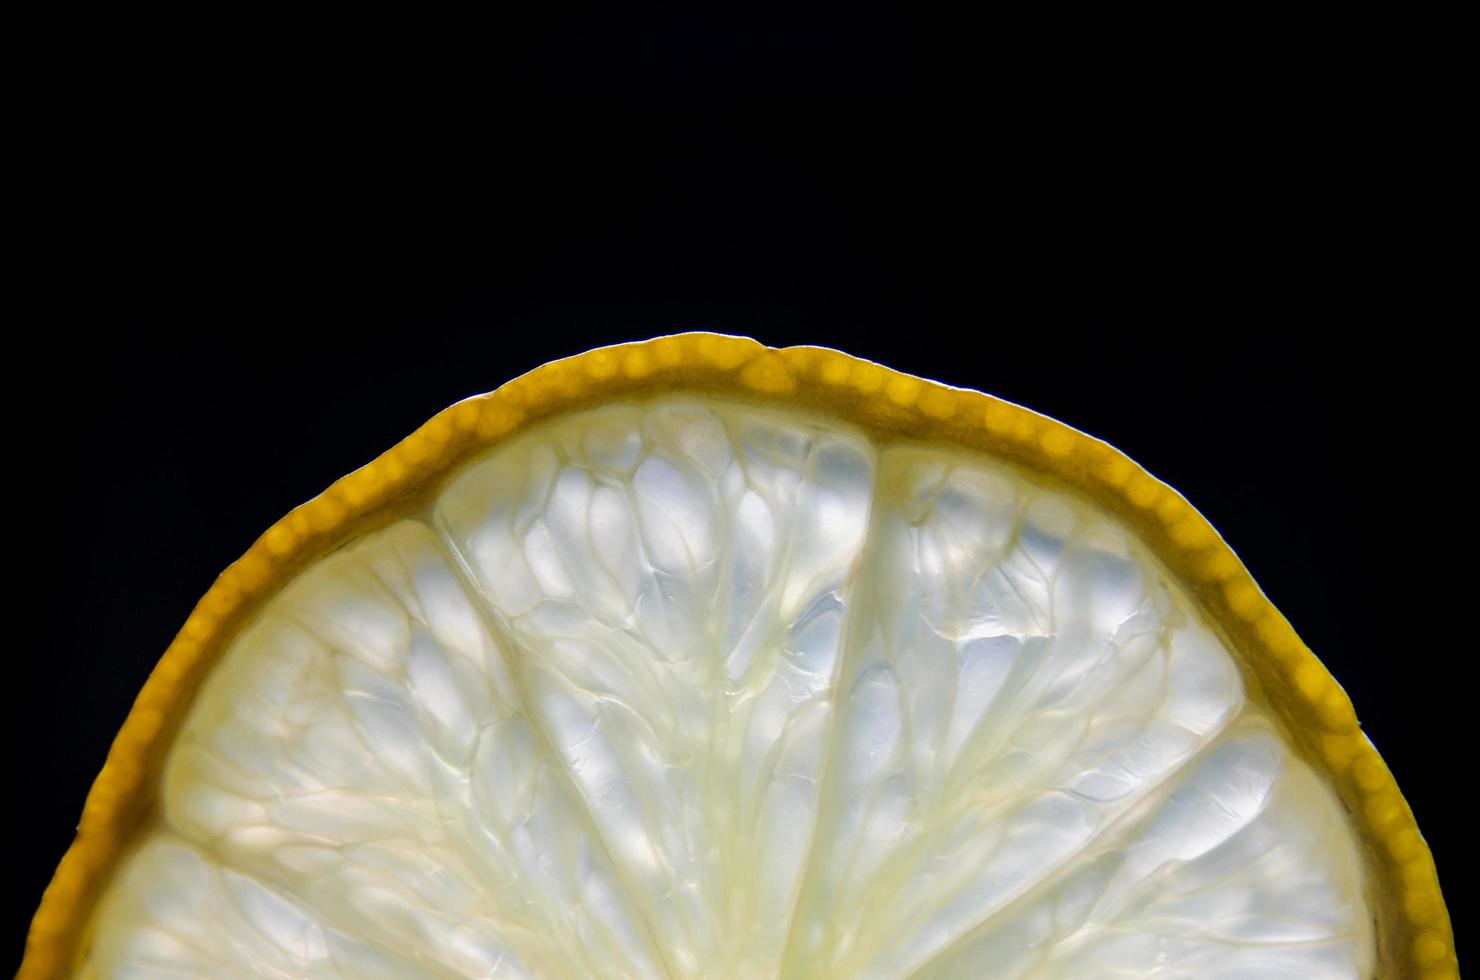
[[929, 718, 1373, 980]]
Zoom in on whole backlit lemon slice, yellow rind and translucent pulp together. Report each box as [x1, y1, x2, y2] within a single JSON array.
[[21, 335, 1458, 980]]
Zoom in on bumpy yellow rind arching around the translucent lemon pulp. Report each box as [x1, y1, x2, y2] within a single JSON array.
[[18, 333, 1459, 980]]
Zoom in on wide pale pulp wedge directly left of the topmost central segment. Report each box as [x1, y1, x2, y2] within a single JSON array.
[[105, 521, 657, 977]]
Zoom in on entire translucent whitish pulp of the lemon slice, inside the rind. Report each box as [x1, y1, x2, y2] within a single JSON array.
[[78, 398, 1372, 977]]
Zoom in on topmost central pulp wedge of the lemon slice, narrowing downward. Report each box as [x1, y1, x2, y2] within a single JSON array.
[[435, 403, 873, 976]]
